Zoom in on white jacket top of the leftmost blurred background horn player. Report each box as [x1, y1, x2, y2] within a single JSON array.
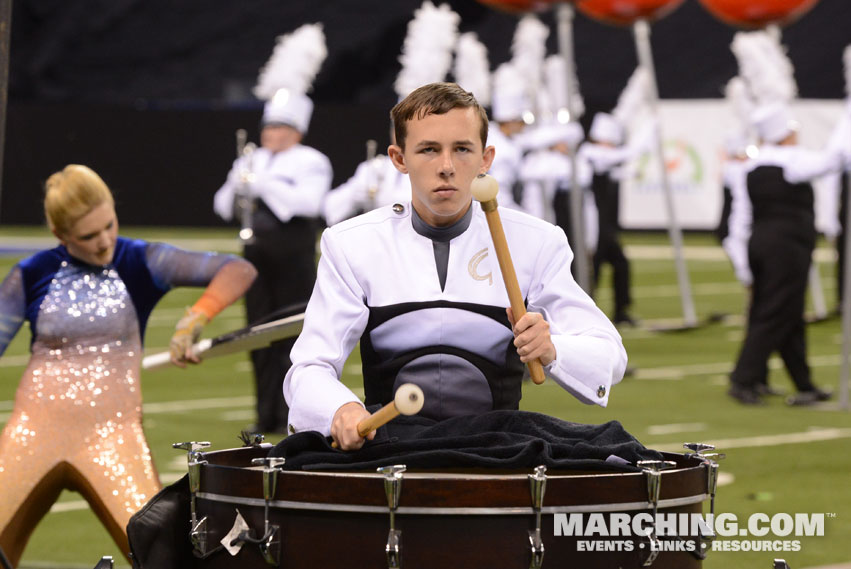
[[213, 144, 333, 223]]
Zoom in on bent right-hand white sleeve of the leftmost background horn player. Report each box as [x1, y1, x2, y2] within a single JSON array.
[[252, 154, 332, 222]]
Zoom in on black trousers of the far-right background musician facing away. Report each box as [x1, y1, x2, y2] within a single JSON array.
[[731, 228, 815, 391]]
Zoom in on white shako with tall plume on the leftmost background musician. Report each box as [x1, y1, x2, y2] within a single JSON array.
[[254, 24, 328, 134]]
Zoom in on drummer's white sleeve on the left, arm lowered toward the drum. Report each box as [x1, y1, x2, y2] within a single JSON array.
[[284, 230, 369, 436]]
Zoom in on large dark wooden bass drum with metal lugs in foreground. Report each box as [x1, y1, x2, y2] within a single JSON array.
[[175, 443, 722, 569]]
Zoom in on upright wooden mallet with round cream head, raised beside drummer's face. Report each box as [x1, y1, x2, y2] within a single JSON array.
[[470, 174, 546, 385]]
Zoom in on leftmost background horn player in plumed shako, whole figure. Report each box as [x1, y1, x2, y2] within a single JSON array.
[[214, 24, 332, 433]]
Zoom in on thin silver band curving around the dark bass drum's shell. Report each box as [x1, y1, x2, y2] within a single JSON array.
[[197, 492, 709, 516]]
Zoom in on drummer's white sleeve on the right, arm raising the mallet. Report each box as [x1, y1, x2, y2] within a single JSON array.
[[528, 222, 627, 407]]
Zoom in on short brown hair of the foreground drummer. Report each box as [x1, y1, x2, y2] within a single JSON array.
[[390, 83, 488, 150]]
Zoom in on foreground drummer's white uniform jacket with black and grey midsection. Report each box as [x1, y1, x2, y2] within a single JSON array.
[[284, 202, 627, 435]]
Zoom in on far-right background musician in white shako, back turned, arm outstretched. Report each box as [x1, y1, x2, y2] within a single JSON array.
[[724, 103, 840, 405]]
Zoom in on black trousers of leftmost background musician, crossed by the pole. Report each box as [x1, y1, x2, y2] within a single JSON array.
[[245, 209, 316, 432]]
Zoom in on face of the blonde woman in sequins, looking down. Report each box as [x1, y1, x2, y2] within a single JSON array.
[[57, 203, 118, 266]]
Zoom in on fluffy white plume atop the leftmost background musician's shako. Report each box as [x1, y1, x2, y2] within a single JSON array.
[[254, 24, 328, 101]]
